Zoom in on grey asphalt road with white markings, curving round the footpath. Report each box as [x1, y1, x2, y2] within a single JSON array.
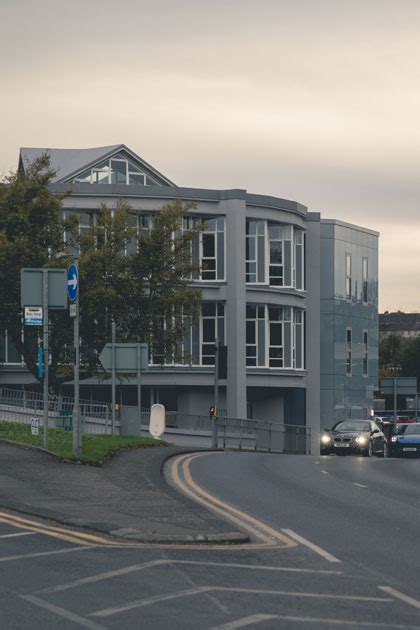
[[0, 453, 420, 630]]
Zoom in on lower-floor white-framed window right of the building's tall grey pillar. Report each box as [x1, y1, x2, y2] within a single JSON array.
[[246, 304, 304, 370]]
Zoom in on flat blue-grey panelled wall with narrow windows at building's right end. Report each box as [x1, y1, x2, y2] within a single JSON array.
[[321, 219, 378, 427]]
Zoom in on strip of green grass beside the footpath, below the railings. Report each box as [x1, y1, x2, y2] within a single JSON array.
[[0, 422, 167, 462]]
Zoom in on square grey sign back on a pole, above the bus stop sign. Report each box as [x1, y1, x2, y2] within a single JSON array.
[[20, 269, 67, 309]]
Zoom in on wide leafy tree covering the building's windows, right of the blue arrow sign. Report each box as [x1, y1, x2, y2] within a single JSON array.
[[66, 200, 202, 374]]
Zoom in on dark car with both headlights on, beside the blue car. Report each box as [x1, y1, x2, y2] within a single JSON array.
[[321, 420, 388, 457]]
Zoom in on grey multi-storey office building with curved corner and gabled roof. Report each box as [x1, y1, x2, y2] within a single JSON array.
[[0, 145, 378, 448]]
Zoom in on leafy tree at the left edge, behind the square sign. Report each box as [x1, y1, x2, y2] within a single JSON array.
[[0, 155, 66, 390]]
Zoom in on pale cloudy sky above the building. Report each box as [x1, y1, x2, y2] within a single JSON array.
[[0, 0, 420, 311]]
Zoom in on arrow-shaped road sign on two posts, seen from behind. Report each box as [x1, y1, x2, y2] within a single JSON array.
[[99, 344, 149, 435]]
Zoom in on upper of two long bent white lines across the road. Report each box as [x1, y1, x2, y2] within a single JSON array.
[[37, 560, 343, 593]]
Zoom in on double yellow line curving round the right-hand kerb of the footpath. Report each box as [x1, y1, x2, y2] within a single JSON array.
[[171, 453, 297, 549]]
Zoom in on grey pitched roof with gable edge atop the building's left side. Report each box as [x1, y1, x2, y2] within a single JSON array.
[[19, 144, 175, 186]]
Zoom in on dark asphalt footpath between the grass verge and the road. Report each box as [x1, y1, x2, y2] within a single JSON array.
[[0, 443, 247, 544]]
